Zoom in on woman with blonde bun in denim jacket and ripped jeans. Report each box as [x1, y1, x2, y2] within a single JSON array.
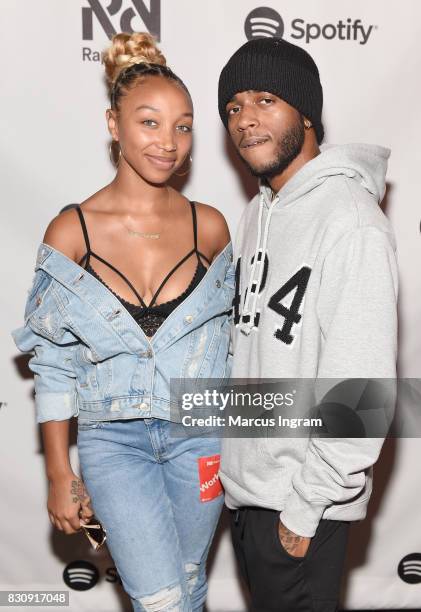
[[13, 33, 233, 611]]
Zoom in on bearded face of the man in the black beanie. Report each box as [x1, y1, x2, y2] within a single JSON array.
[[226, 90, 304, 179]]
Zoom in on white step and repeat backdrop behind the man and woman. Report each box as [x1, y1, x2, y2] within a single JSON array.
[[0, 0, 421, 612]]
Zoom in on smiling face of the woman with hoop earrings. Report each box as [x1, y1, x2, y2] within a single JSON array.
[[107, 75, 193, 184]]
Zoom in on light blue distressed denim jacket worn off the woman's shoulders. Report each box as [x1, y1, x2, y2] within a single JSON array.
[[12, 243, 234, 423]]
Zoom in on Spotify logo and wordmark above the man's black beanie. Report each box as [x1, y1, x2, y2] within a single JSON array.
[[244, 6, 377, 45]]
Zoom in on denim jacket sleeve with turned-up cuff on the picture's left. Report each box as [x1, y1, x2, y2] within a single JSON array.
[[12, 271, 79, 423]]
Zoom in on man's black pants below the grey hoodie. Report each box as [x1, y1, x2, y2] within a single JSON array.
[[230, 507, 349, 612]]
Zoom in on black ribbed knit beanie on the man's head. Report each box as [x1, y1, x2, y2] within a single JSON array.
[[218, 38, 324, 144]]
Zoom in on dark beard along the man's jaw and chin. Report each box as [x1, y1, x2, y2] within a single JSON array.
[[241, 121, 305, 179]]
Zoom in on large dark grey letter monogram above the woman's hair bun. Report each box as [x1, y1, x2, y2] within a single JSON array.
[[82, 0, 161, 40]]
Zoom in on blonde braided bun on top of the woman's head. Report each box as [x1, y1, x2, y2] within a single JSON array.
[[102, 32, 167, 86]]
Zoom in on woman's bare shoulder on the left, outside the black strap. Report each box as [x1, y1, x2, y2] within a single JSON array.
[[43, 208, 84, 261]]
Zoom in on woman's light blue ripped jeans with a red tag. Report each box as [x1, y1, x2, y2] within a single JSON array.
[[77, 418, 223, 612]]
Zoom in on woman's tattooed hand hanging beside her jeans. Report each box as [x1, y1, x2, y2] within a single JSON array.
[[47, 472, 94, 534]]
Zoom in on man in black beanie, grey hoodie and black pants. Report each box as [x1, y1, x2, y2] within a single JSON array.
[[219, 38, 397, 612]]
